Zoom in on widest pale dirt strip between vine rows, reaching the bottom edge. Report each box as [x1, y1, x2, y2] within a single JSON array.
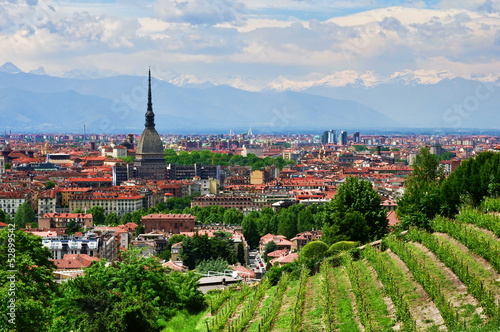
[[387, 249, 447, 331]]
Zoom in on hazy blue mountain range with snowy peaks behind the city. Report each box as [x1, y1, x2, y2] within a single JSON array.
[[0, 63, 500, 134]]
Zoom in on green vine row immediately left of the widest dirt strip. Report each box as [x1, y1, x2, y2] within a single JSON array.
[[363, 246, 414, 331]]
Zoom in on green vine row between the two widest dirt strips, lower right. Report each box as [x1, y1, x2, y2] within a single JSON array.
[[385, 236, 458, 330]]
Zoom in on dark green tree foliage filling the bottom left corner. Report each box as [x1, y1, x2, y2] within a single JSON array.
[[0, 227, 57, 332]]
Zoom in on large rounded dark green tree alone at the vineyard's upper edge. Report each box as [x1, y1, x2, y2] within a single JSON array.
[[322, 177, 388, 245]]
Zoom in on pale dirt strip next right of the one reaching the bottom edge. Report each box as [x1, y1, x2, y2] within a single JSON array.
[[411, 242, 486, 320]]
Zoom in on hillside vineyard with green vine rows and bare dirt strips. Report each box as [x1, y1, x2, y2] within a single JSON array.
[[165, 209, 500, 332]]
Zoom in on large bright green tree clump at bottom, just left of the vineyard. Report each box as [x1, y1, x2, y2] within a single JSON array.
[[53, 251, 204, 331]]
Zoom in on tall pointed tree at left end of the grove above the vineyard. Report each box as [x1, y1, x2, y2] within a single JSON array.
[[396, 147, 444, 228]]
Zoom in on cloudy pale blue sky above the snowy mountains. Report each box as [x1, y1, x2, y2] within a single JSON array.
[[0, 0, 500, 90]]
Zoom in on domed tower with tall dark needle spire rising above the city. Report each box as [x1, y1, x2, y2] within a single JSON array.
[[134, 69, 167, 180]]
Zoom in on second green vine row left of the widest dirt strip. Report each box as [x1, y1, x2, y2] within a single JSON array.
[[346, 255, 395, 331]]
